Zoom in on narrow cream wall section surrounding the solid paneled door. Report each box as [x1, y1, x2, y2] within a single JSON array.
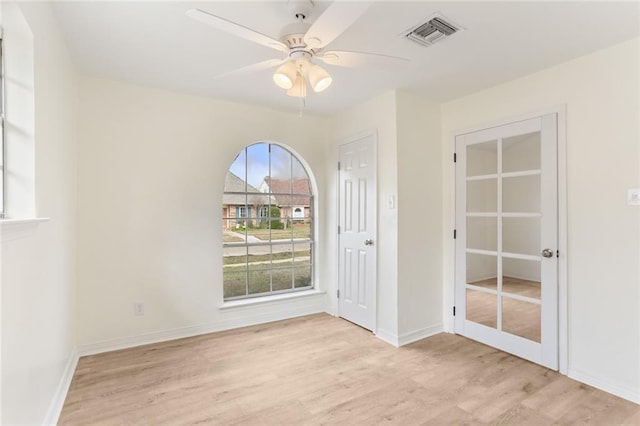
[[325, 92, 398, 344]]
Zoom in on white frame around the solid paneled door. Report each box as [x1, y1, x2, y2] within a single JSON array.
[[332, 130, 380, 335]]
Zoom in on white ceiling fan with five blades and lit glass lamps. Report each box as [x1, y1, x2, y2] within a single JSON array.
[[186, 0, 408, 98]]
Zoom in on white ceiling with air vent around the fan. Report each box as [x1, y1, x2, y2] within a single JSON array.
[[53, 0, 640, 114]]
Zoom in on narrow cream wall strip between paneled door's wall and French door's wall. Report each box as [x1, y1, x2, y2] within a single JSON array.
[[396, 92, 442, 344]]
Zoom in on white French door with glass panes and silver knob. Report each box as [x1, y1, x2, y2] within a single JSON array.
[[455, 114, 558, 370]]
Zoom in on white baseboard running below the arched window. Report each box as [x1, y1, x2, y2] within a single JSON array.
[[78, 300, 325, 356]]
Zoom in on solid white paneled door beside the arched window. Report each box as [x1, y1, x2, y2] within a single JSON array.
[[338, 135, 376, 331]]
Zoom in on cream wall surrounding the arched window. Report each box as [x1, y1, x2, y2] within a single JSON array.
[[78, 78, 329, 353]]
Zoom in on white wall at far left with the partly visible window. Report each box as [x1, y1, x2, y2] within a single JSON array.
[[0, 3, 77, 425]]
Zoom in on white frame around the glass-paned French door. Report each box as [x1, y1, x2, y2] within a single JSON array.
[[444, 104, 569, 375]]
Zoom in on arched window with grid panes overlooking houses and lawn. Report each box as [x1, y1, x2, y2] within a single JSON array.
[[222, 143, 314, 300]]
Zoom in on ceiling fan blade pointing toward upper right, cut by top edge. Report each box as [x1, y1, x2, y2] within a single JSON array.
[[304, 1, 371, 48]]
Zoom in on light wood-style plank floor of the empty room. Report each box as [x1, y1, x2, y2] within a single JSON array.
[[59, 314, 640, 425]]
